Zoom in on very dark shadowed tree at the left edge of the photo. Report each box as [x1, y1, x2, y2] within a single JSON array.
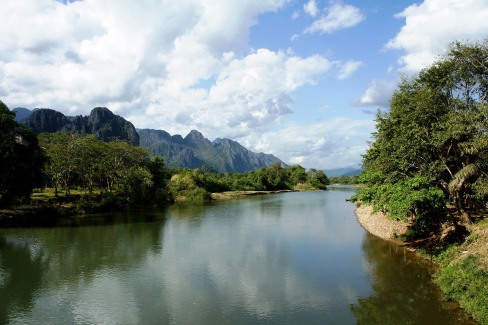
[[0, 101, 46, 207]]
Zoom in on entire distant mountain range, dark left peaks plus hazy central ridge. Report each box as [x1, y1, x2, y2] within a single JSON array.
[[13, 107, 284, 172]]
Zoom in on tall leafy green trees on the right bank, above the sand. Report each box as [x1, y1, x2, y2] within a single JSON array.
[[354, 40, 488, 231]]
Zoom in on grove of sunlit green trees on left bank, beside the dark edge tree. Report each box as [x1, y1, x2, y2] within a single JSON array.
[[39, 132, 169, 206]]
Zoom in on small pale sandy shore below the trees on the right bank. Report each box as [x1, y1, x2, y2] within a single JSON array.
[[356, 205, 407, 240]]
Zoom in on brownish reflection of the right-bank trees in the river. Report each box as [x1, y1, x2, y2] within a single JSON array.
[[351, 235, 474, 324]]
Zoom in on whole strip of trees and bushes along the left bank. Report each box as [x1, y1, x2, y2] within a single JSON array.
[[0, 97, 329, 226]]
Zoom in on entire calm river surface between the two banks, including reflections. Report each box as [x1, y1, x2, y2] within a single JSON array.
[[0, 188, 472, 324]]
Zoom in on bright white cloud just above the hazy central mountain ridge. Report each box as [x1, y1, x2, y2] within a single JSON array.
[[128, 49, 335, 138]]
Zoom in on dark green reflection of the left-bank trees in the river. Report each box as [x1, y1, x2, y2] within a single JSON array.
[[0, 213, 164, 324]]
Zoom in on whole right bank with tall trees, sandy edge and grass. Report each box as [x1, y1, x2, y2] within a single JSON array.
[[352, 40, 488, 324]]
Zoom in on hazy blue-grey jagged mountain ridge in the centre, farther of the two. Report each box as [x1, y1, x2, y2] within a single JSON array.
[[137, 129, 283, 173]]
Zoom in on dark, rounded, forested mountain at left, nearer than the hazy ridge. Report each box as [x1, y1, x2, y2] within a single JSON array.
[[23, 107, 139, 146]]
